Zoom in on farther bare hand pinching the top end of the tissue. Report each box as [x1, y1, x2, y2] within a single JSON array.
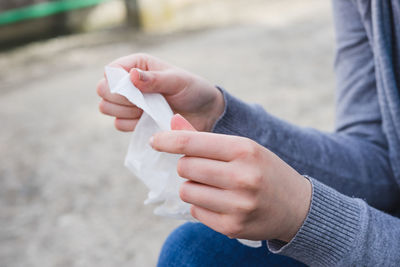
[[97, 54, 225, 131]]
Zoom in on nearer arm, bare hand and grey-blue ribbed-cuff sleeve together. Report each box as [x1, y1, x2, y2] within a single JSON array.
[[155, 116, 400, 266]]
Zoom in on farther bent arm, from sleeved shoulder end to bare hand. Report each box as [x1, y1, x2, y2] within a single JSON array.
[[98, 0, 400, 212]]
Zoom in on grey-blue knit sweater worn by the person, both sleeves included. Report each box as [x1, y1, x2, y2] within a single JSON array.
[[214, 0, 400, 266]]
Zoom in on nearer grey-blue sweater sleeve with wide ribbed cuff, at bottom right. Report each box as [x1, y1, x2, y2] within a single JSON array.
[[268, 179, 400, 266]]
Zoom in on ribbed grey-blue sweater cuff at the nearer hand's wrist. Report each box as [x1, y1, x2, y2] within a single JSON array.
[[267, 177, 362, 266]]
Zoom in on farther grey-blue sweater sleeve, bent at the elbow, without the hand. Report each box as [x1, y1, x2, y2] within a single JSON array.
[[214, 0, 400, 212]]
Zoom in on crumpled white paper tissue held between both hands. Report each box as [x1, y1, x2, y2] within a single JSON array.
[[105, 67, 261, 247]]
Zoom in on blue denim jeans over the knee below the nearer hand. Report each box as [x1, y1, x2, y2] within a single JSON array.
[[157, 223, 305, 267]]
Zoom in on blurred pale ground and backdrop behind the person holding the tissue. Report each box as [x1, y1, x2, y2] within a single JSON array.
[[0, 0, 334, 267]]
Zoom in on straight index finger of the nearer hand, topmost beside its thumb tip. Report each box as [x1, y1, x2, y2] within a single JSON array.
[[150, 131, 241, 161]]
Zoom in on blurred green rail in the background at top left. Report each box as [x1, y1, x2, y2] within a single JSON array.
[[0, 0, 109, 26]]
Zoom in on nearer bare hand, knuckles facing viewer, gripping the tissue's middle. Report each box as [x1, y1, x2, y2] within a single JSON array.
[[151, 115, 311, 242]]
